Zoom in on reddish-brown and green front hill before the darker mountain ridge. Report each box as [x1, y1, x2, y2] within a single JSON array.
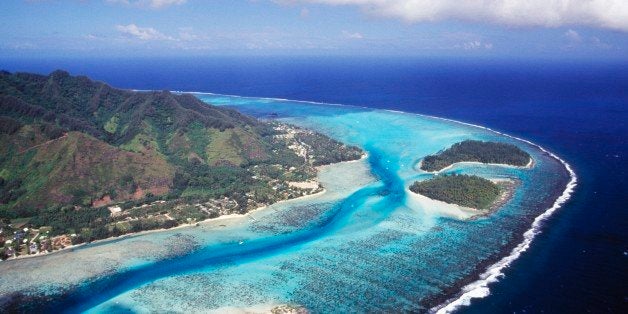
[[2, 132, 174, 212]]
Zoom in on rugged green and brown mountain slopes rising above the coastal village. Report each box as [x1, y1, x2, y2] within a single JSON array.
[[0, 71, 269, 215]]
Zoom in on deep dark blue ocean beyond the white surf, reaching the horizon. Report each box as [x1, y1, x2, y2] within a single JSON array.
[[0, 57, 628, 313]]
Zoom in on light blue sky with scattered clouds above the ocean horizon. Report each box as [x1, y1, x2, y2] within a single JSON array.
[[0, 0, 628, 59]]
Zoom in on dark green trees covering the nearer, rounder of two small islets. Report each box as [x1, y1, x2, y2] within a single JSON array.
[[410, 174, 500, 209]]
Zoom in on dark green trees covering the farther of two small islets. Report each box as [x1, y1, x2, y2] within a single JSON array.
[[421, 140, 531, 171]]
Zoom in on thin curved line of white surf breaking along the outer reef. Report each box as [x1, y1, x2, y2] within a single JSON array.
[[138, 90, 578, 314]]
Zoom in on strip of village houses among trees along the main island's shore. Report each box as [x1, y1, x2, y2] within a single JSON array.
[[0, 123, 362, 260]]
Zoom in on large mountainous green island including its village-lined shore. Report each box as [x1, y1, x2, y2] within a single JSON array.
[[0, 71, 362, 255]]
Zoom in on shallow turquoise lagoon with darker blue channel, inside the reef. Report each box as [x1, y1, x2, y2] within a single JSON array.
[[0, 94, 575, 313]]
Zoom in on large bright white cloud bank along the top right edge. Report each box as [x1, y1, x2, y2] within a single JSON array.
[[292, 0, 628, 32]]
